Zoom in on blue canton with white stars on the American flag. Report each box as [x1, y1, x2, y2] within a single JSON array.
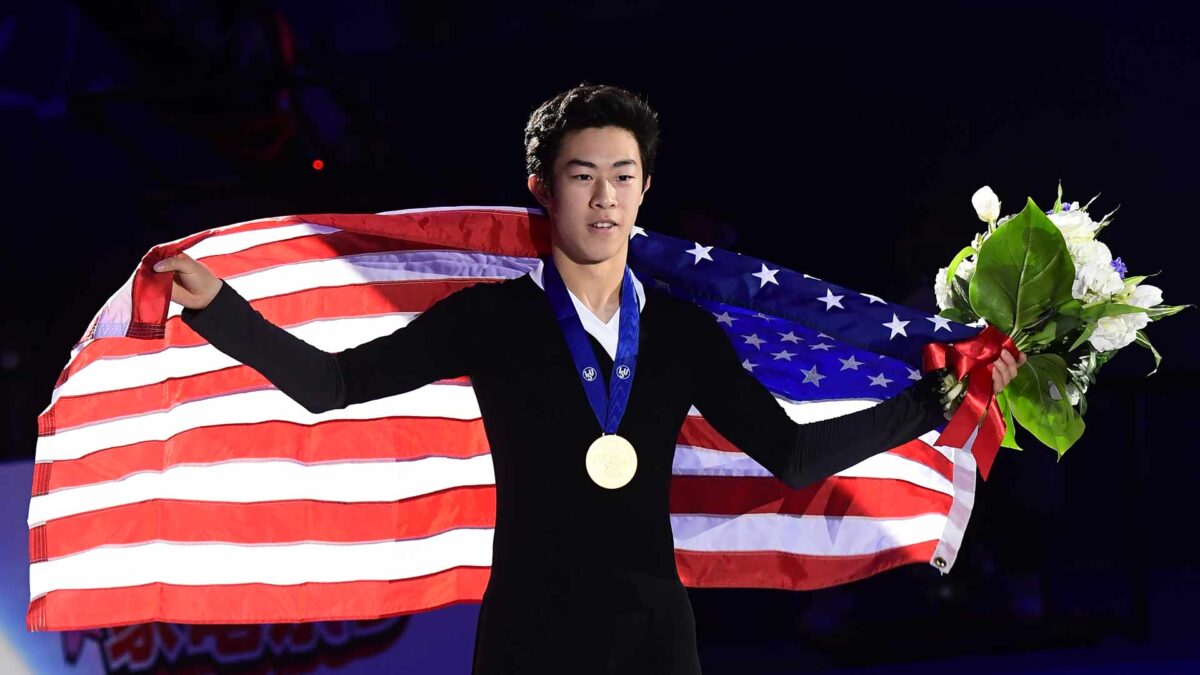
[[629, 226, 983, 400]]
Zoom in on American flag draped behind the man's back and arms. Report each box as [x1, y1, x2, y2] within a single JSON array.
[[26, 207, 979, 631]]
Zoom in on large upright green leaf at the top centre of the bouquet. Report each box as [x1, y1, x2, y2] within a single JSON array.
[[968, 199, 1075, 335]]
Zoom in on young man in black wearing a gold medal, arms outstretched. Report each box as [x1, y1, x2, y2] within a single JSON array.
[[155, 85, 1019, 674]]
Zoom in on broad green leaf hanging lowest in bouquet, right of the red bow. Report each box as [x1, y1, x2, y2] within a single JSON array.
[[1008, 354, 1084, 459]]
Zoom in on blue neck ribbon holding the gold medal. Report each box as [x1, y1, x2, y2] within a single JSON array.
[[542, 257, 640, 434]]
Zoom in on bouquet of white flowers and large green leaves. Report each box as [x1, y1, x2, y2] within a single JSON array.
[[934, 184, 1192, 458]]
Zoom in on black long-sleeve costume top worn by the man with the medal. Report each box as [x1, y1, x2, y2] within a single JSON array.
[[182, 270, 944, 673]]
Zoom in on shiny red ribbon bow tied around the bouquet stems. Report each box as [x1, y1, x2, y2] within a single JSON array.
[[922, 325, 1021, 480]]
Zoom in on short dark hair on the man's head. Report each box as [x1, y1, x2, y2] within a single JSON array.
[[526, 82, 659, 190]]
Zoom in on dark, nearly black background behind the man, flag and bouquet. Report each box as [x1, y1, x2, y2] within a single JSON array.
[[0, 0, 1200, 673]]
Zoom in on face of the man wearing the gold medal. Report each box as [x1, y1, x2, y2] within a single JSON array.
[[529, 126, 650, 264]]
